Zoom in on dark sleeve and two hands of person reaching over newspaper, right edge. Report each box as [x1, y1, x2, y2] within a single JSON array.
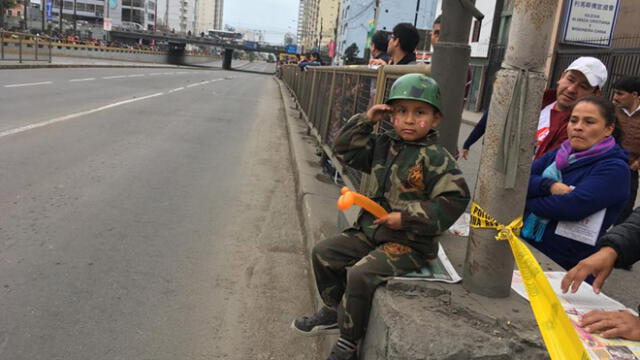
[[561, 207, 640, 340]]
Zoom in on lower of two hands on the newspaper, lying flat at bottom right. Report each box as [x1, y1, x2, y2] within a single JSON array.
[[579, 310, 640, 340]]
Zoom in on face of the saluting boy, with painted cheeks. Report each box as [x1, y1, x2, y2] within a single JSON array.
[[391, 100, 442, 141]]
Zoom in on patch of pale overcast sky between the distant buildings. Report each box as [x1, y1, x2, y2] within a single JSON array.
[[223, 0, 300, 43]]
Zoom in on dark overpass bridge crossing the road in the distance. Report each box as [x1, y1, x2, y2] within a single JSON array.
[[109, 29, 285, 70]]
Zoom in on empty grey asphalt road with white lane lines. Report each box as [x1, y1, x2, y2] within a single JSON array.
[[0, 63, 317, 360]]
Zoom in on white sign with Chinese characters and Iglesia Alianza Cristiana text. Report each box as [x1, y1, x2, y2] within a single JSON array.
[[562, 0, 620, 47]]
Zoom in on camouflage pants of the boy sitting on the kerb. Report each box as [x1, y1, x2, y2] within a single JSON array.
[[311, 229, 426, 341]]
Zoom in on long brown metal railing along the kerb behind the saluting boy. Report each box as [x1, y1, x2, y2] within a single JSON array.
[[281, 65, 431, 193]]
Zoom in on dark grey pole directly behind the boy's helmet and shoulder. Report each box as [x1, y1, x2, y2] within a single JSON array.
[[431, 0, 483, 154]]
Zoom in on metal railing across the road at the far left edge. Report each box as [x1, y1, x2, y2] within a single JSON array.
[[0, 30, 53, 63]]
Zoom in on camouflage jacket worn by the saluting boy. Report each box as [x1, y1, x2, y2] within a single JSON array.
[[334, 114, 470, 259]]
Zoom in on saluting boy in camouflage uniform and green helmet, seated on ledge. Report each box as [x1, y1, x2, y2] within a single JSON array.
[[292, 74, 470, 360]]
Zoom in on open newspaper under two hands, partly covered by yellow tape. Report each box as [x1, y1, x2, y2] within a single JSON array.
[[511, 270, 640, 360]]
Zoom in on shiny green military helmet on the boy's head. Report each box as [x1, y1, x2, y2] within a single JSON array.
[[386, 73, 442, 112]]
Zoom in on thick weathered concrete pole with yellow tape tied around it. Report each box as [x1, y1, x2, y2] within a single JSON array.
[[464, 0, 558, 297]]
